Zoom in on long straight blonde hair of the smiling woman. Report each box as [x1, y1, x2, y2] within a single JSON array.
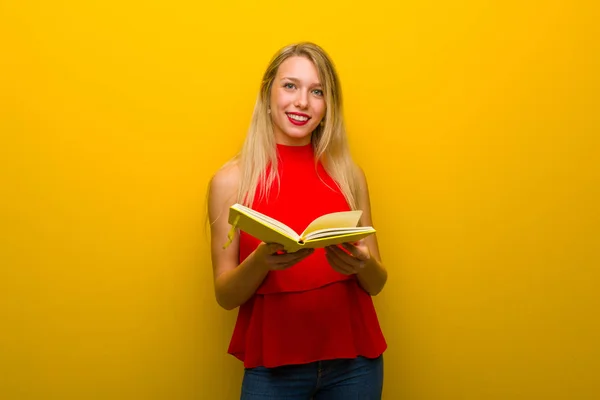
[[228, 42, 358, 209]]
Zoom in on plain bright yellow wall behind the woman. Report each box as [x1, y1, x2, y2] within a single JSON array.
[[0, 0, 600, 400]]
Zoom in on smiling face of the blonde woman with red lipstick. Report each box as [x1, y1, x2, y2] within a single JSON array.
[[271, 56, 325, 146]]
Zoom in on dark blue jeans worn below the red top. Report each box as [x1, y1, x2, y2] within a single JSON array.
[[241, 356, 383, 400]]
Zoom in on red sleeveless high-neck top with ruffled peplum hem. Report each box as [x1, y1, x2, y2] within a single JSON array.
[[228, 144, 387, 368]]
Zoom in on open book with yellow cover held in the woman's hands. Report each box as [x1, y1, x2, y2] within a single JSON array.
[[224, 204, 375, 252]]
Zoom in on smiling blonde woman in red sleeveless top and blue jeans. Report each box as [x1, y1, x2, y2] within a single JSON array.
[[208, 43, 387, 400]]
